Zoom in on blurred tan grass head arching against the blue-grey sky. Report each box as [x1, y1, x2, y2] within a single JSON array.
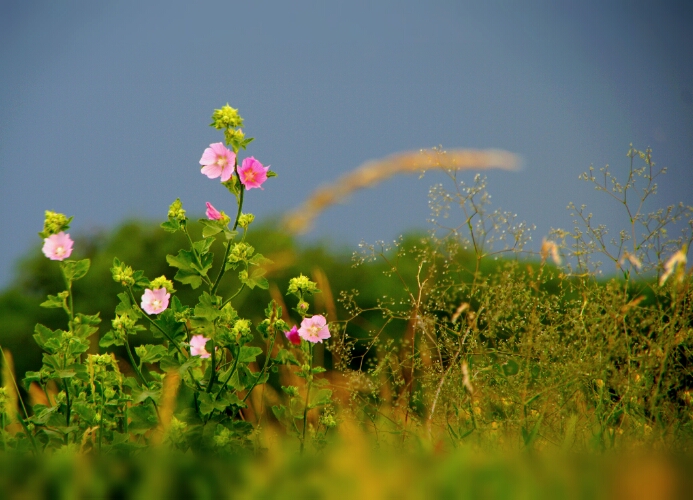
[[285, 149, 520, 233]]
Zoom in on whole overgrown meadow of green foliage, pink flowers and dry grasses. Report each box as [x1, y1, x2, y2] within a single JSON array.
[[0, 105, 693, 498]]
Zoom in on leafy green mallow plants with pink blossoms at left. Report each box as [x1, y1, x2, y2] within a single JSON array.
[[0, 105, 330, 454]]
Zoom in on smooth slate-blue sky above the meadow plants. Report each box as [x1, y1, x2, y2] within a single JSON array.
[[0, 0, 693, 287]]
